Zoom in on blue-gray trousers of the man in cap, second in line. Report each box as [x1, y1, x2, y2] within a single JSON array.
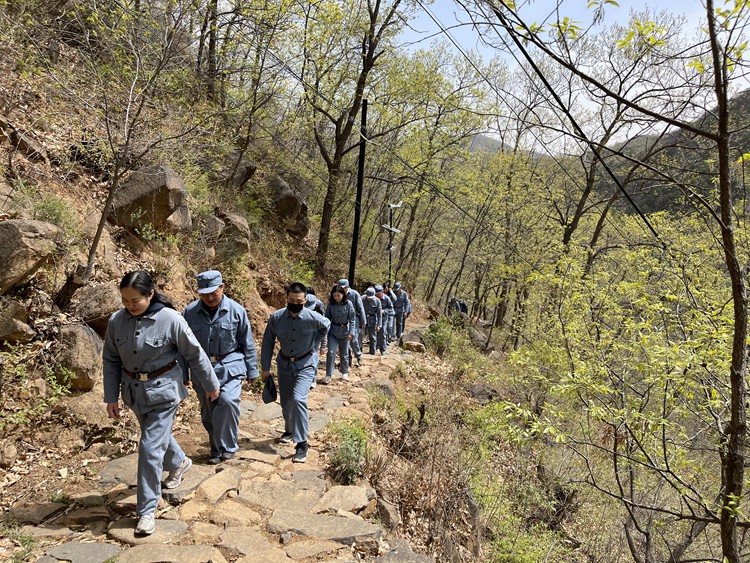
[[193, 377, 244, 457]]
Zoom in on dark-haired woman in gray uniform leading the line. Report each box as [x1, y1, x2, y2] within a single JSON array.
[[102, 270, 219, 535]]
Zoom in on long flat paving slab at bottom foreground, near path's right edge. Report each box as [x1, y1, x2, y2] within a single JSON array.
[[268, 510, 383, 545]]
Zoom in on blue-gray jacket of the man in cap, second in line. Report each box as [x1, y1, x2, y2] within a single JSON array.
[[180, 295, 258, 385]]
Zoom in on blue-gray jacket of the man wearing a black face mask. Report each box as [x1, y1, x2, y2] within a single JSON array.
[[260, 307, 331, 371]]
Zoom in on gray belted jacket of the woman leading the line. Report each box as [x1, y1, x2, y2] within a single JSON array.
[[102, 308, 219, 414]]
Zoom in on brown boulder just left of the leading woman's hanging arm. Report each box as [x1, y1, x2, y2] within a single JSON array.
[[58, 324, 103, 391]]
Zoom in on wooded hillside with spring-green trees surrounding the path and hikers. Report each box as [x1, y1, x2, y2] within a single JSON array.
[[0, 0, 750, 563]]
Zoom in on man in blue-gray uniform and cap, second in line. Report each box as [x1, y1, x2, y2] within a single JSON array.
[[180, 270, 258, 465]]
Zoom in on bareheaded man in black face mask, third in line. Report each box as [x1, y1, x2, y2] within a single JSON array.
[[260, 282, 331, 463]]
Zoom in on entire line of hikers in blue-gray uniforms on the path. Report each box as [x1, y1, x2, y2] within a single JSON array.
[[103, 270, 411, 535]]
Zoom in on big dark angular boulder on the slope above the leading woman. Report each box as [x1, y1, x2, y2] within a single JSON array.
[[111, 165, 192, 232]]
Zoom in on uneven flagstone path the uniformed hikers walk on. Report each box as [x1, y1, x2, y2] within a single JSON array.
[[7, 340, 431, 563]]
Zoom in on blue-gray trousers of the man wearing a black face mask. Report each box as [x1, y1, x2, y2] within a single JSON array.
[[276, 357, 317, 444]]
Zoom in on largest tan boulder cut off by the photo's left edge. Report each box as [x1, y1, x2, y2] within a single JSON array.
[[0, 219, 63, 295]]
